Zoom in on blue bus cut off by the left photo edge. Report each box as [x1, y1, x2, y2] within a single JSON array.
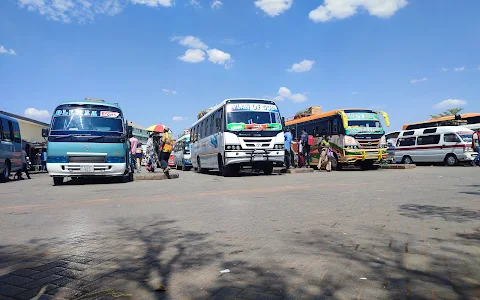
[[0, 114, 22, 182]]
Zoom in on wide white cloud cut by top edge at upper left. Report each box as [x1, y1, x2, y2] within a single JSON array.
[[15, 0, 173, 23]]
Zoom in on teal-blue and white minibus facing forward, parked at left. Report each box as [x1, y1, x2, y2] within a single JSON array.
[[43, 100, 130, 185]]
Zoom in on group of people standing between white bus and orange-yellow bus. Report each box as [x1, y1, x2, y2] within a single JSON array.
[[284, 129, 334, 172]]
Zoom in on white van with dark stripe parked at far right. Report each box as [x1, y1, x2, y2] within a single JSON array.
[[395, 126, 477, 166]]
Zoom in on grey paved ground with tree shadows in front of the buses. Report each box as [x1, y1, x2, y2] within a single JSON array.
[[0, 167, 480, 299]]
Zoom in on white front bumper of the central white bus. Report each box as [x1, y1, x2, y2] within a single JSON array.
[[225, 150, 285, 166]]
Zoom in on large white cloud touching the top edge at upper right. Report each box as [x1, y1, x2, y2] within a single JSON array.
[[308, 0, 408, 23]]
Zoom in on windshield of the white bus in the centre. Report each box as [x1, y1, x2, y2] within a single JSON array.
[[227, 104, 282, 131]]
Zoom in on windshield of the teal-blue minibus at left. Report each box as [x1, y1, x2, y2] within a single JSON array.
[[51, 107, 124, 135]]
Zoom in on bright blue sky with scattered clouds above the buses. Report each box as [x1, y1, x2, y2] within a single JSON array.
[[0, 0, 480, 132]]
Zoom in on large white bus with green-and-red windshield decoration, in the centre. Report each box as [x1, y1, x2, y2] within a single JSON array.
[[190, 98, 284, 176]]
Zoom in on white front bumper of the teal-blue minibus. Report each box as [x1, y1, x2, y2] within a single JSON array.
[[47, 163, 127, 177]]
